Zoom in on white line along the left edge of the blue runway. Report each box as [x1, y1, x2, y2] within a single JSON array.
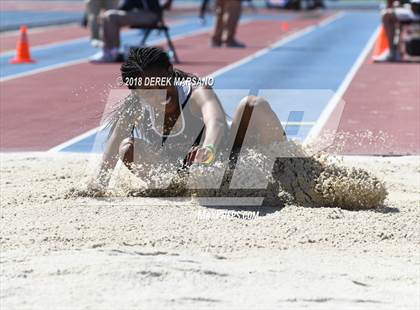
[[48, 12, 345, 152]]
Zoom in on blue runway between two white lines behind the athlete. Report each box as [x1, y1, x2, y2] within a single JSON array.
[[63, 12, 379, 152]]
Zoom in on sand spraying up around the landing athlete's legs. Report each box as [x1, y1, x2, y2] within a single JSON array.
[[68, 141, 387, 210]]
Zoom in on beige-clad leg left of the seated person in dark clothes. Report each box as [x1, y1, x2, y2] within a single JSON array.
[[85, 0, 118, 47]]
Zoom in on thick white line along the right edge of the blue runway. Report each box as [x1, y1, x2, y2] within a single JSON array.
[[303, 27, 380, 145]]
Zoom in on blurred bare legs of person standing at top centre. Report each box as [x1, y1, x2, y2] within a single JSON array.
[[211, 0, 245, 47]]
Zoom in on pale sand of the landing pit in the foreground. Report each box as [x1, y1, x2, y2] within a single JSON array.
[[0, 154, 420, 309]]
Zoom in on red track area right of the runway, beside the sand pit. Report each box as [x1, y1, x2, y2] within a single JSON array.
[[324, 56, 420, 155]]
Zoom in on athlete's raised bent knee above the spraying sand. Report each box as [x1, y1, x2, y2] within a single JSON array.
[[230, 96, 287, 148]]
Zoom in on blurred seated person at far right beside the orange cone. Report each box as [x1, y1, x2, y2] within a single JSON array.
[[374, 0, 420, 62]]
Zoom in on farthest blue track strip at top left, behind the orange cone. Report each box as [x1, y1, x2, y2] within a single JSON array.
[[0, 11, 83, 31]]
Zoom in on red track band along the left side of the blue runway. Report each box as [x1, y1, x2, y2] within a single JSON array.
[[0, 18, 328, 151]]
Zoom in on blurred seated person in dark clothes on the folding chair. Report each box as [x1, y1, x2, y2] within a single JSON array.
[[92, 0, 172, 62]]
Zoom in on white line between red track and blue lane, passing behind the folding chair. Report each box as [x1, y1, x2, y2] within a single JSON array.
[[0, 19, 252, 82]]
